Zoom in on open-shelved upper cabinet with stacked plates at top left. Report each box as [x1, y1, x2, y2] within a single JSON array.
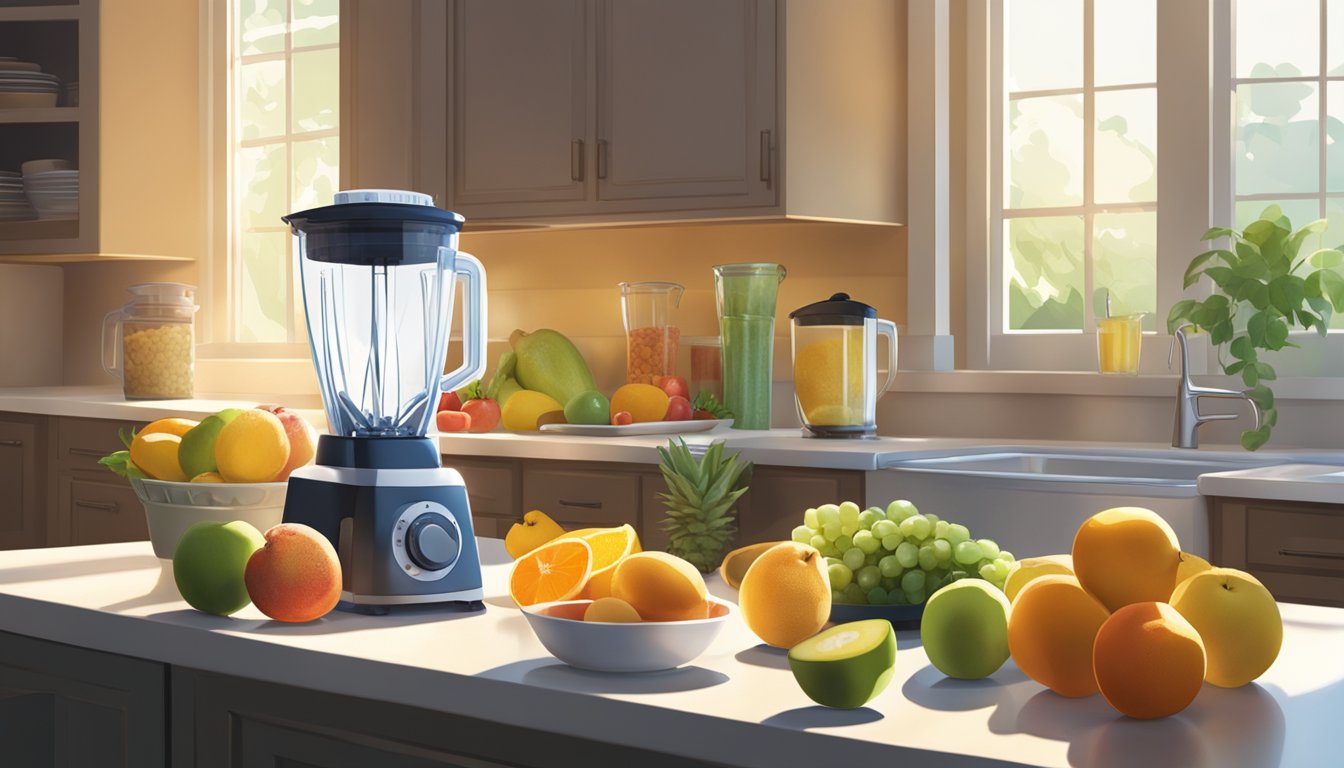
[[0, 0, 204, 262]]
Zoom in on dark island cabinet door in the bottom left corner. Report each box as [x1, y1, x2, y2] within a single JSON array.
[[0, 632, 168, 768]]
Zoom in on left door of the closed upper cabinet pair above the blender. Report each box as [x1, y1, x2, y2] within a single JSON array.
[[450, 0, 590, 212]]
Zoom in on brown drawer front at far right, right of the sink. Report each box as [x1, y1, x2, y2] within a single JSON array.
[[1246, 504, 1344, 572]]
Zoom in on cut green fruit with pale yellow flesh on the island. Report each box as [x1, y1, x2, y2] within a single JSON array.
[[789, 619, 896, 709]]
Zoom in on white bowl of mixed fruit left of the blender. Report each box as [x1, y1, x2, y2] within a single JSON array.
[[130, 479, 289, 560]]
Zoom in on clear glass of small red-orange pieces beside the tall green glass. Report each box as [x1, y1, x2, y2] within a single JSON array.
[[620, 281, 685, 385]]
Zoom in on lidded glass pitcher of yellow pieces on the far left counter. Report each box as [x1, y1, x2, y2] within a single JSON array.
[[102, 282, 200, 399]]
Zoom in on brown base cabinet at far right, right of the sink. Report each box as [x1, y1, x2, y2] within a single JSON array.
[[1208, 496, 1344, 608]]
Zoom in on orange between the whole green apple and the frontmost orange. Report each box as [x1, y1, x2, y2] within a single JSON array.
[[1008, 573, 1109, 697]]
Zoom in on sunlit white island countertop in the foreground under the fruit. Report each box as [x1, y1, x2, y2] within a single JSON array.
[[0, 539, 1344, 768]]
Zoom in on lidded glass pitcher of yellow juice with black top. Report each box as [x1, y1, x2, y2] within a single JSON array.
[[789, 293, 896, 437]]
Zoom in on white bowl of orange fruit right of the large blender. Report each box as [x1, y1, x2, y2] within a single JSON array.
[[523, 597, 737, 673]]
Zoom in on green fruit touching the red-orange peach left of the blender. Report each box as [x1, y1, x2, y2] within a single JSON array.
[[172, 521, 266, 616]]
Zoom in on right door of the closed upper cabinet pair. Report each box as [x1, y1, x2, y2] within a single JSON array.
[[597, 0, 778, 210]]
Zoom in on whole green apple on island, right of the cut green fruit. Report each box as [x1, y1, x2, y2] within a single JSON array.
[[919, 578, 1009, 681]]
